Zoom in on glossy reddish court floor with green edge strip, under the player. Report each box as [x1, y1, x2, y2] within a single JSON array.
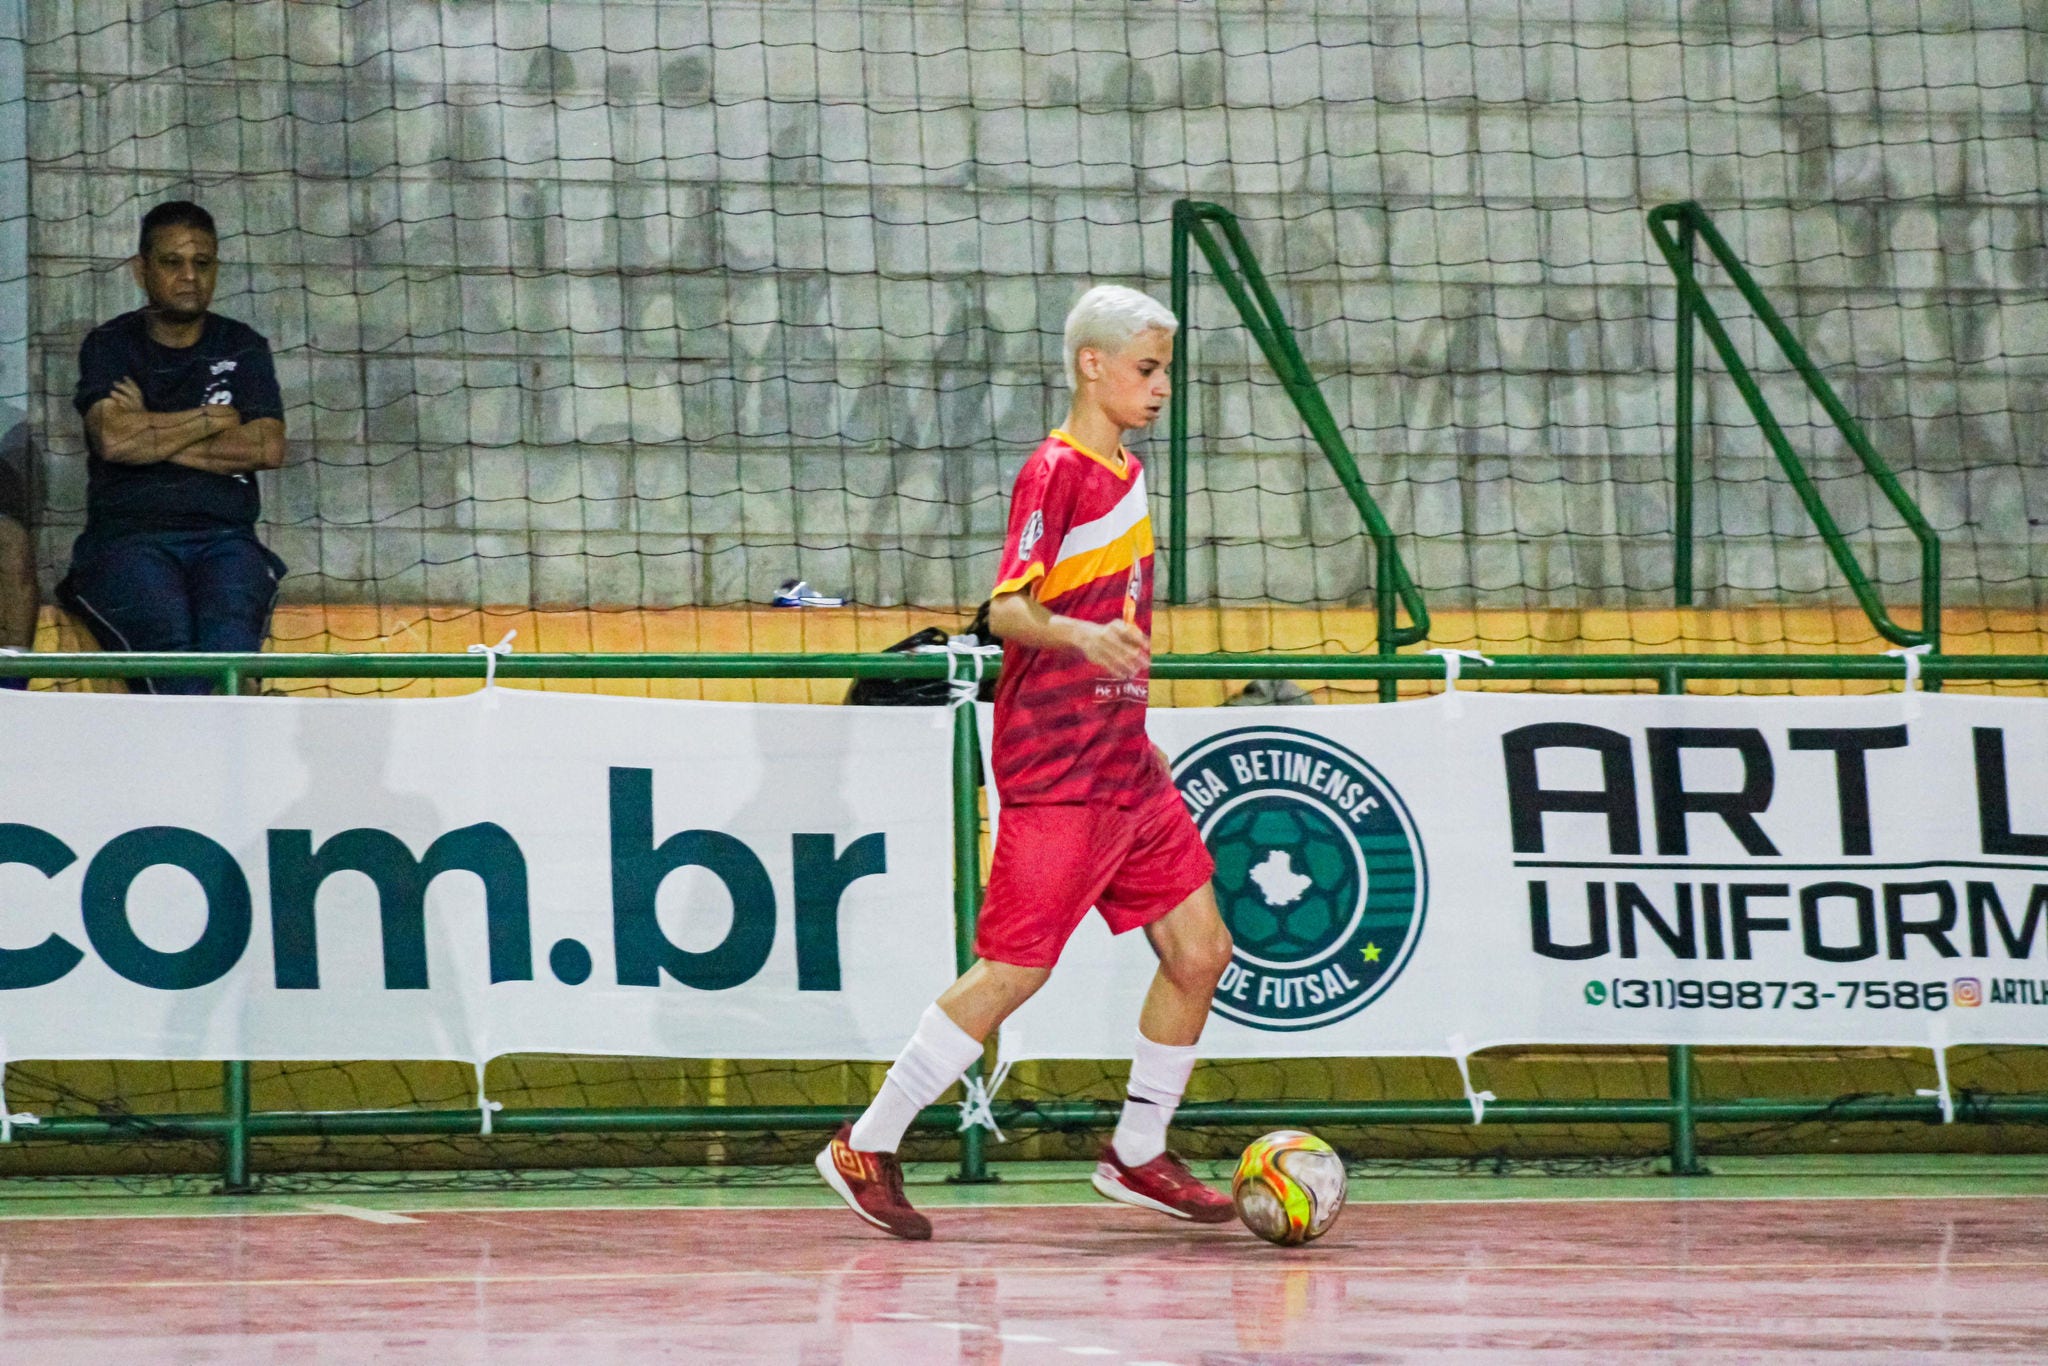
[[0, 1161, 2048, 1366]]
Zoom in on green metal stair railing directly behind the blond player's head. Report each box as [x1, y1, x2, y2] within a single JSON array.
[[1165, 199, 1430, 702]]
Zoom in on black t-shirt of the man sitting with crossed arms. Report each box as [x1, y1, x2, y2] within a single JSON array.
[[72, 309, 285, 535]]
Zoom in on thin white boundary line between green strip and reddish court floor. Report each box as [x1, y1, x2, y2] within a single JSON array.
[[0, 1178, 2048, 1223]]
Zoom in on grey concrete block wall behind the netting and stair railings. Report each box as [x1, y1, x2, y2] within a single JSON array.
[[27, 0, 2048, 606]]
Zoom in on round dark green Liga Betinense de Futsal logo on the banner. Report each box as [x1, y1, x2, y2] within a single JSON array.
[[1174, 725, 1430, 1030]]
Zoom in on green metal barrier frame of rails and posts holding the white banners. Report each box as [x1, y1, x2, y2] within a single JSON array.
[[0, 653, 2048, 1192]]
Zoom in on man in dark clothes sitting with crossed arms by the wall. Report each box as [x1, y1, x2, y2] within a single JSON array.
[[57, 201, 285, 692]]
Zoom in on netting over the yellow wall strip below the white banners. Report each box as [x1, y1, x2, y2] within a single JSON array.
[[0, 1049, 2048, 1190]]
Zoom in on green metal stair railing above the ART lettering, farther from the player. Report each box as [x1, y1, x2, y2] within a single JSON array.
[[1649, 201, 1942, 649]]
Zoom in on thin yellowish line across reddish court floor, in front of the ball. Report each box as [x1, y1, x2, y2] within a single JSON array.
[[8, 1260, 2048, 1290]]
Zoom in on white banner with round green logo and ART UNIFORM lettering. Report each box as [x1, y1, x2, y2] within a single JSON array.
[[1001, 692, 2048, 1059]]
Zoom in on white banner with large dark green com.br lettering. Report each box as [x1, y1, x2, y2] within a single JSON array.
[[0, 688, 954, 1061]]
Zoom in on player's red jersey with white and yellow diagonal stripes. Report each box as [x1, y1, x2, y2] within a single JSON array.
[[993, 432, 1159, 807]]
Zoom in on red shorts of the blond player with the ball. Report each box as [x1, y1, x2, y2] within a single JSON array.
[[975, 782, 1217, 967]]
